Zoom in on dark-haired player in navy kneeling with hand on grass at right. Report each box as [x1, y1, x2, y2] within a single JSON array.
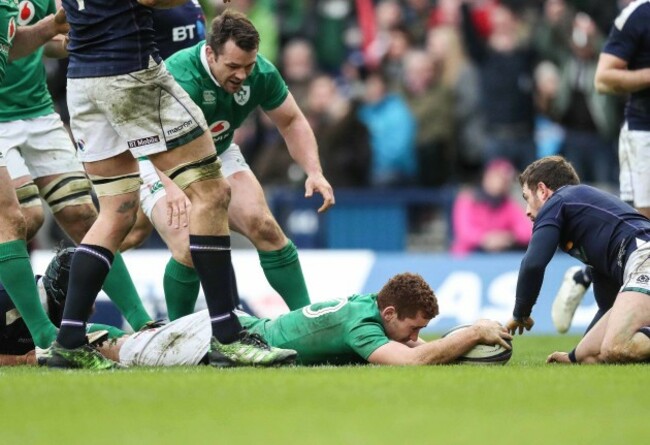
[[506, 156, 650, 363]]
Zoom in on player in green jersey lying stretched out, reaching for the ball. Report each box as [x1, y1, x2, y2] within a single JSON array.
[[0, 253, 511, 366]]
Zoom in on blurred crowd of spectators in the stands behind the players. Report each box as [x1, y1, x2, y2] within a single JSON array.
[[40, 0, 629, 253]]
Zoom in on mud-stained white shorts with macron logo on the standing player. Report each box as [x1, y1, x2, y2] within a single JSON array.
[[68, 59, 207, 162]]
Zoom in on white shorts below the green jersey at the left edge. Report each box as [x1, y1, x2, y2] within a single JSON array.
[[0, 113, 84, 179]]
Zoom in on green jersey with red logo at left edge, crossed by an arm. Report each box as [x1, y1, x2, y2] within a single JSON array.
[[0, 0, 56, 122]]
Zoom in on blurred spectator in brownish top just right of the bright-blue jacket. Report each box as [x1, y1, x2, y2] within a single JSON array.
[[401, 50, 455, 186]]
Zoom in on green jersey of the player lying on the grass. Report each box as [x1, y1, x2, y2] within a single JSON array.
[[238, 294, 390, 365]]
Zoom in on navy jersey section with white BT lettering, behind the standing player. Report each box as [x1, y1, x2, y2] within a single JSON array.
[[153, 0, 205, 59]]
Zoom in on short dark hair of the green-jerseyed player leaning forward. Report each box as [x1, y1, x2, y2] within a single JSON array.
[[208, 9, 260, 54]]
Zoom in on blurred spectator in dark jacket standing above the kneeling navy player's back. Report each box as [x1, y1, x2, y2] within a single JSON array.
[[551, 13, 621, 185]]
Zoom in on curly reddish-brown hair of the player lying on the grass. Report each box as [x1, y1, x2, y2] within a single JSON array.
[[377, 272, 438, 320]]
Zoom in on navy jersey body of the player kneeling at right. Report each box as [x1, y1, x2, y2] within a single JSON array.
[[527, 184, 650, 280]]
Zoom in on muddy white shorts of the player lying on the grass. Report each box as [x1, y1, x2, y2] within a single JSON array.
[[120, 309, 212, 366]]
